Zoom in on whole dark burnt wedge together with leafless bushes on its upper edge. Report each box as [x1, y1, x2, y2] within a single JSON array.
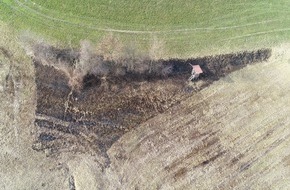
[[24, 29, 271, 162]]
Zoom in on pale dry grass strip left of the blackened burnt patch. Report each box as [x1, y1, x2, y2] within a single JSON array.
[[0, 21, 68, 190]]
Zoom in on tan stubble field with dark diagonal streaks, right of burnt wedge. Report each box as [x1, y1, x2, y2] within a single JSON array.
[[101, 45, 290, 189]]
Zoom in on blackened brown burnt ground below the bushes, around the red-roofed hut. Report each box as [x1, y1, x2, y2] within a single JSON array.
[[33, 49, 271, 162]]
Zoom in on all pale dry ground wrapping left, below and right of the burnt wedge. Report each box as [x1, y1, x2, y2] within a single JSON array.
[[0, 17, 290, 190]]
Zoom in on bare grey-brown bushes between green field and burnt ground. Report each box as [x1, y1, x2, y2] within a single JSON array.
[[22, 34, 172, 90]]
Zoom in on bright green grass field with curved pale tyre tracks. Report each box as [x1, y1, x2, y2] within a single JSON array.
[[0, 0, 290, 57]]
